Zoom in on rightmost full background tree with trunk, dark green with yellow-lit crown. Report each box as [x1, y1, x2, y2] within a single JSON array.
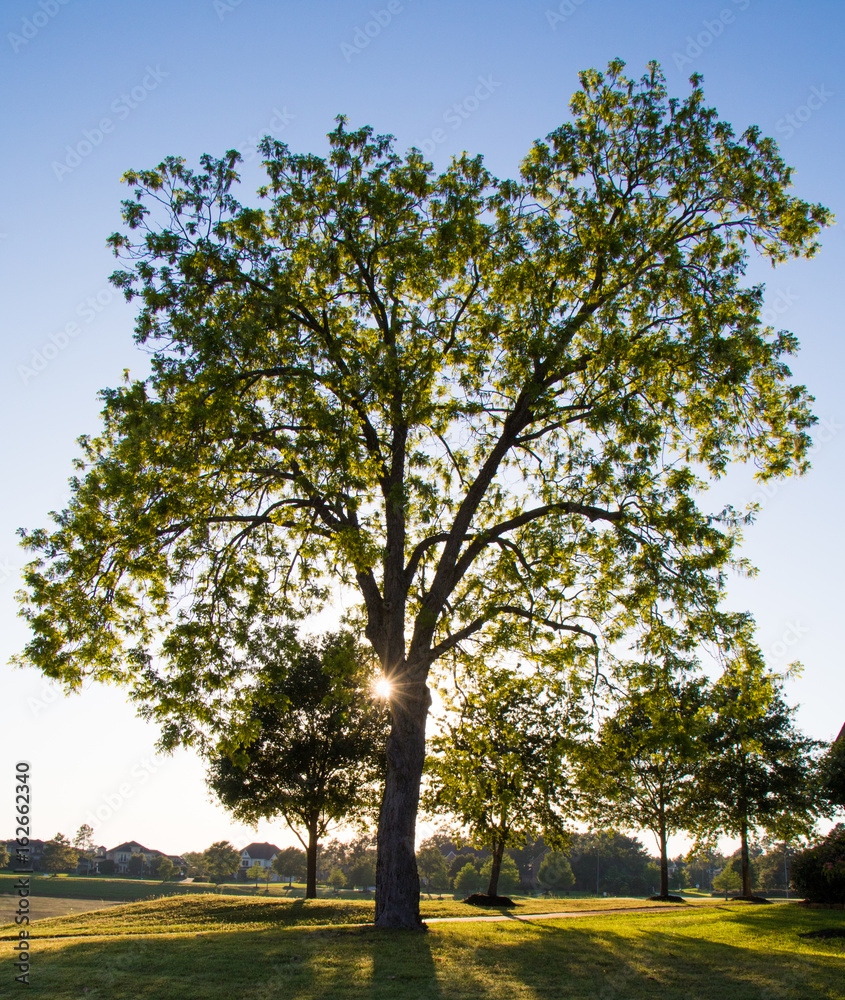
[[696, 664, 829, 896]]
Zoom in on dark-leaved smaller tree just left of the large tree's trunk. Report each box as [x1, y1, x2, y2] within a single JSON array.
[[208, 625, 389, 898]]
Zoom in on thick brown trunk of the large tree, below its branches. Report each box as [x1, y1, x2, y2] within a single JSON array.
[[376, 669, 431, 929]]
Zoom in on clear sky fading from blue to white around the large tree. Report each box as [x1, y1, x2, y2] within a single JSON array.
[[0, 0, 845, 853]]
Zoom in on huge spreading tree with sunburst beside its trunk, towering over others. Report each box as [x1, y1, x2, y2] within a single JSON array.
[[16, 60, 828, 927]]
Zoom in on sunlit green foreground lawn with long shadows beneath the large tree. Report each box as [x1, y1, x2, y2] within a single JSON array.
[[0, 897, 845, 1000]]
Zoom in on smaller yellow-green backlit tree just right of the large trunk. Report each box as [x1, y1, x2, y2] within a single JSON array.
[[423, 662, 577, 896]]
